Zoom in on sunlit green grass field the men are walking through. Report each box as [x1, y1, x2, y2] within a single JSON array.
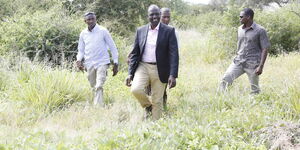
[[0, 29, 300, 150]]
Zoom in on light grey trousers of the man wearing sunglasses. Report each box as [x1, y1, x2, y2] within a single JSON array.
[[219, 63, 260, 94]]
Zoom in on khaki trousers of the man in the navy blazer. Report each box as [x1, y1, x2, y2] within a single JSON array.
[[131, 62, 166, 120]]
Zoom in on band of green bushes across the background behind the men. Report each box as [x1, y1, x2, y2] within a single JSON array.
[[0, 0, 300, 64]]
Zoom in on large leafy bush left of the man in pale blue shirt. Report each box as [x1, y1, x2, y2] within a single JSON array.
[[0, 8, 83, 63]]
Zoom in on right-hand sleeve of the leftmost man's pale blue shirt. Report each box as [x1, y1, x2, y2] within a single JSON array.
[[104, 30, 119, 63]]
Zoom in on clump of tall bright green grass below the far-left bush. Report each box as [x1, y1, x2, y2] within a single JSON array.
[[1, 57, 91, 111]]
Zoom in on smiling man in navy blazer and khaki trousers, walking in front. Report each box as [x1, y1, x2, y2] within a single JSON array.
[[126, 5, 179, 120]]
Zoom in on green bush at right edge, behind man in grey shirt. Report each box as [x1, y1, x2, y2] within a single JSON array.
[[256, 4, 300, 55]]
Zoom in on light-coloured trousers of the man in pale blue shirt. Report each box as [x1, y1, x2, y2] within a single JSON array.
[[87, 65, 109, 106]]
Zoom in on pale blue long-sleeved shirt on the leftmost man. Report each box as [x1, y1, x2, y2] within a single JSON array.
[[77, 24, 118, 69]]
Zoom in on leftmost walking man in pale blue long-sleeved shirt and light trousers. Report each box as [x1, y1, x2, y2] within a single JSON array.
[[76, 12, 118, 106]]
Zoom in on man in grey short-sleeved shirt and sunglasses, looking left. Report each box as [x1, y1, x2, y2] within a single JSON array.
[[219, 8, 270, 94]]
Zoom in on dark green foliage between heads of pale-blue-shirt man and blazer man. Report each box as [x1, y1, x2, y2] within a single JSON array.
[[63, 0, 164, 36]]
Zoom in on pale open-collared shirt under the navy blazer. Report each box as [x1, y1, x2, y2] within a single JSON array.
[[142, 23, 160, 63]]
